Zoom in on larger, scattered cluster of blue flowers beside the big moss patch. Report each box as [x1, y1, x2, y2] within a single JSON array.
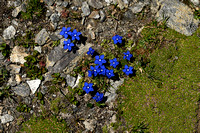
[[83, 35, 133, 102]]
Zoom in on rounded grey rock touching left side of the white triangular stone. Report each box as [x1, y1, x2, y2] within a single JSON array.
[[13, 83, 31, 97]]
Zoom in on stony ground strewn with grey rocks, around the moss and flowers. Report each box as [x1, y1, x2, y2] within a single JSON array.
[[0, 0, 200, 133]]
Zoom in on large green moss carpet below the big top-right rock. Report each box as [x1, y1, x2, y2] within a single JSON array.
[[119, 26, 200, 133]]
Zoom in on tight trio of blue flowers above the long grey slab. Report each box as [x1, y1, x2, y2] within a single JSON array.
[[60, 27, 81, 51]]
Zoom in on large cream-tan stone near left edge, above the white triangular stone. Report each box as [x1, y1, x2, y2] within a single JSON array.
[[10, 46, 28, 64]]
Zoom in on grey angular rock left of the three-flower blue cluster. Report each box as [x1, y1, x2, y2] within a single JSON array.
[[35, 28, 49, 45]]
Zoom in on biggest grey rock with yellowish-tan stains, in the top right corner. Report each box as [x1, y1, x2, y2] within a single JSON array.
[[156, 0, 199, 36]]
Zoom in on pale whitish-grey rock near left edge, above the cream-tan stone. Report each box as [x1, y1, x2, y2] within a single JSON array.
[[3, 25, 16, 39]]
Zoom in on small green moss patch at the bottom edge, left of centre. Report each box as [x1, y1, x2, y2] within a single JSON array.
[[20, 117, 67, 133]]
